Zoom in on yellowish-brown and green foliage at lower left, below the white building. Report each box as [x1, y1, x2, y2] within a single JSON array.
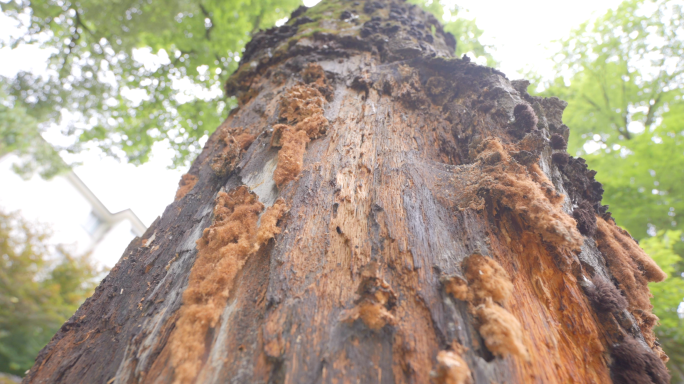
[[0, 211, 99, 375]]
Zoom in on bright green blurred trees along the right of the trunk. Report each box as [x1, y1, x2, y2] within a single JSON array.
[[541, 0, 684, 382]]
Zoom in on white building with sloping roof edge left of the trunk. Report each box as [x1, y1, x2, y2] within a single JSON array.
[[0, 155, 147, 268]]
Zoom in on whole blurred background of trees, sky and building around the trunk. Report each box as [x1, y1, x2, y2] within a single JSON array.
[[0, 0, 684, 383]]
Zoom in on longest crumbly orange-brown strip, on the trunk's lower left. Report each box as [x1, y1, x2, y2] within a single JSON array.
[[168, 186, 286, 383]]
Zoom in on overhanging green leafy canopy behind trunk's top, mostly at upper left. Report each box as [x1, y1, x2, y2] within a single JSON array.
[[0, 0, 491, 174]]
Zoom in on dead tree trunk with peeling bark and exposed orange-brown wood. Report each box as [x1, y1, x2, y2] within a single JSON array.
[[25, 0, 668, 383]]
